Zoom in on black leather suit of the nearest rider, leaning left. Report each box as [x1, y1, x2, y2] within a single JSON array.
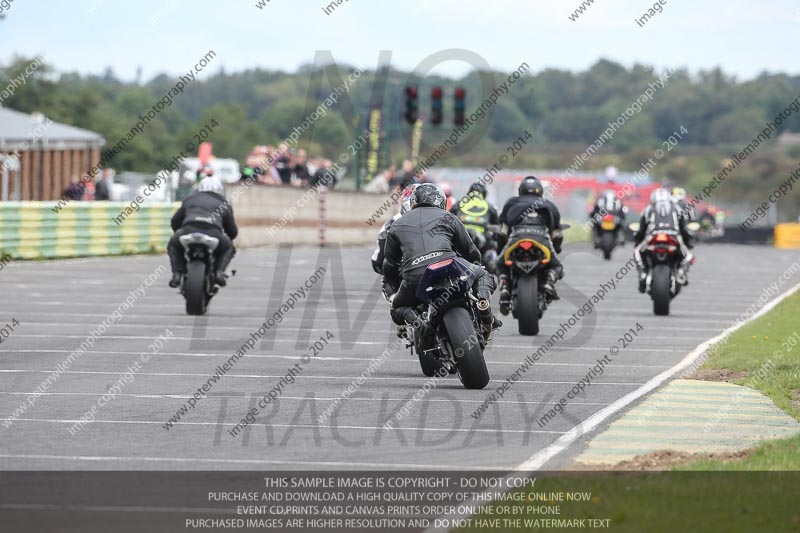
[[383, 206, 496, 325]]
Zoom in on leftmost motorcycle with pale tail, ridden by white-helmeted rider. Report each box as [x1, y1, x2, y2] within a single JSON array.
[[179, 233, 228, 316]]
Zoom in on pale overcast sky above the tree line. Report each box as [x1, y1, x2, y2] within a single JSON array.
[[0, 0, 800, 80]]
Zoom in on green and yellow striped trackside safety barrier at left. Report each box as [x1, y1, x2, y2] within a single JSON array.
[[0, 201, 180, 259]]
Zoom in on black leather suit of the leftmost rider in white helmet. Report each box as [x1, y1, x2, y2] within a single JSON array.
[[167, 191, 239, 273]]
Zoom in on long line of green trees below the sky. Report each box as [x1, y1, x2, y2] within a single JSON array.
[[0, 57, 800, 218]]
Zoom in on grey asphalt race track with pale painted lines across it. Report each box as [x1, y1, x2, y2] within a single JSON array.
[[0, 241, 800, 470]]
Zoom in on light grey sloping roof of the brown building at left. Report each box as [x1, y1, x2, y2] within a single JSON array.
[[0, 108, 105, 150]]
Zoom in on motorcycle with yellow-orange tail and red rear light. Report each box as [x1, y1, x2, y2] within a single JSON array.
[[502, 224, 569, 335]]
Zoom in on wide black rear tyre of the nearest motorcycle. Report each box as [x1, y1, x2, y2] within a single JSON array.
[[443, 307, 489, 389]]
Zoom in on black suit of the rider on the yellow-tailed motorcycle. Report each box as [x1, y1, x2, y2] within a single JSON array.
[[497, 194, 564, 279]]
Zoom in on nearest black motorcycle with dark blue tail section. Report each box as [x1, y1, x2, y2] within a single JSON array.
[[404, 259, 492, 389]]
